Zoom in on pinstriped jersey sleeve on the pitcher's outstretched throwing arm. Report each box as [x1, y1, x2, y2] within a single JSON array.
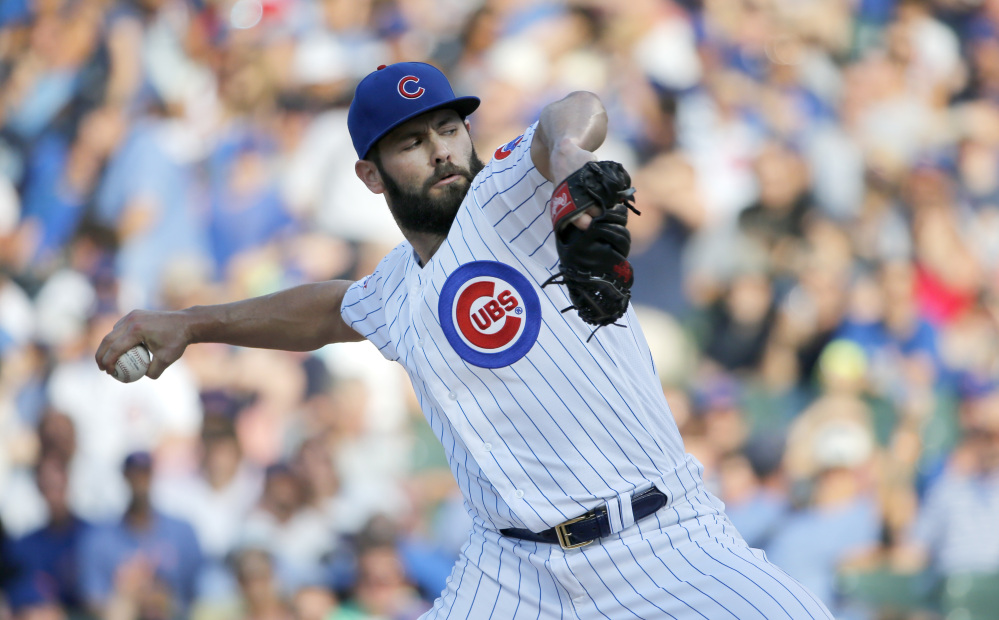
[[340, 244, 407, 361]]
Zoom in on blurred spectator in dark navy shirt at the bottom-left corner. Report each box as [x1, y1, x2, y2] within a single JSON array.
[[7, 452, 90, 611]]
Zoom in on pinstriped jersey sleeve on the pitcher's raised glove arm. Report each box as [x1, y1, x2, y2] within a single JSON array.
[[469, 122, 554, 263]]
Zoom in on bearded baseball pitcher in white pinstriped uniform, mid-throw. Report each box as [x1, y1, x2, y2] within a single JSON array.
[[96, 63, 831, 620]]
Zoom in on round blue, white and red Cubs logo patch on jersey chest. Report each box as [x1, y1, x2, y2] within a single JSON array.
[[437, 261, 541, 368]]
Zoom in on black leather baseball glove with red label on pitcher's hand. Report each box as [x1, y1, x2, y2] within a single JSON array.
[[542, 161, 639, 341]]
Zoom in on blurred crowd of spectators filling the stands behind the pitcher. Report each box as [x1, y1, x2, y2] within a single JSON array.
[[0, 0, 999, 620]]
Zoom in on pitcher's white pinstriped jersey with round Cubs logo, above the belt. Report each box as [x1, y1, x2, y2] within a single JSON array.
[[341, 124, 685, 531]]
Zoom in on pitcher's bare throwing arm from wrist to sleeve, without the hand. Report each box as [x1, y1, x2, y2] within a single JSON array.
[[181, 280, 361, 351]]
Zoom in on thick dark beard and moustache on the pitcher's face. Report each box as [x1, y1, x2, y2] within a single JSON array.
[[375, 148, 485, 235]]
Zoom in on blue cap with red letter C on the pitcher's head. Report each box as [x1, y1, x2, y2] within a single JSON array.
[[347, 62, 480, 159]]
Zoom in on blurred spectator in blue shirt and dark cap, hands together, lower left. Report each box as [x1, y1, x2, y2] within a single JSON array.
[[80, 452, 201, 617]]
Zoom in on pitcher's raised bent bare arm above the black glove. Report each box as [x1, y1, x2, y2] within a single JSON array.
[[531, 91, 607, 183]]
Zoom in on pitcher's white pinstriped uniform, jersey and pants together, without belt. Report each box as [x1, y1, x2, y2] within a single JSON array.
[[341, 124, 829, 620]]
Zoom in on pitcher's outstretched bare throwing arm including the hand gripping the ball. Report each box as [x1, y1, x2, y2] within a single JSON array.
[[96, 280, 363, 379]]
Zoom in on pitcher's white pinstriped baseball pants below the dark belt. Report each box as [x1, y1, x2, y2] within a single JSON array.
[[421, 490, 832, 620]]
